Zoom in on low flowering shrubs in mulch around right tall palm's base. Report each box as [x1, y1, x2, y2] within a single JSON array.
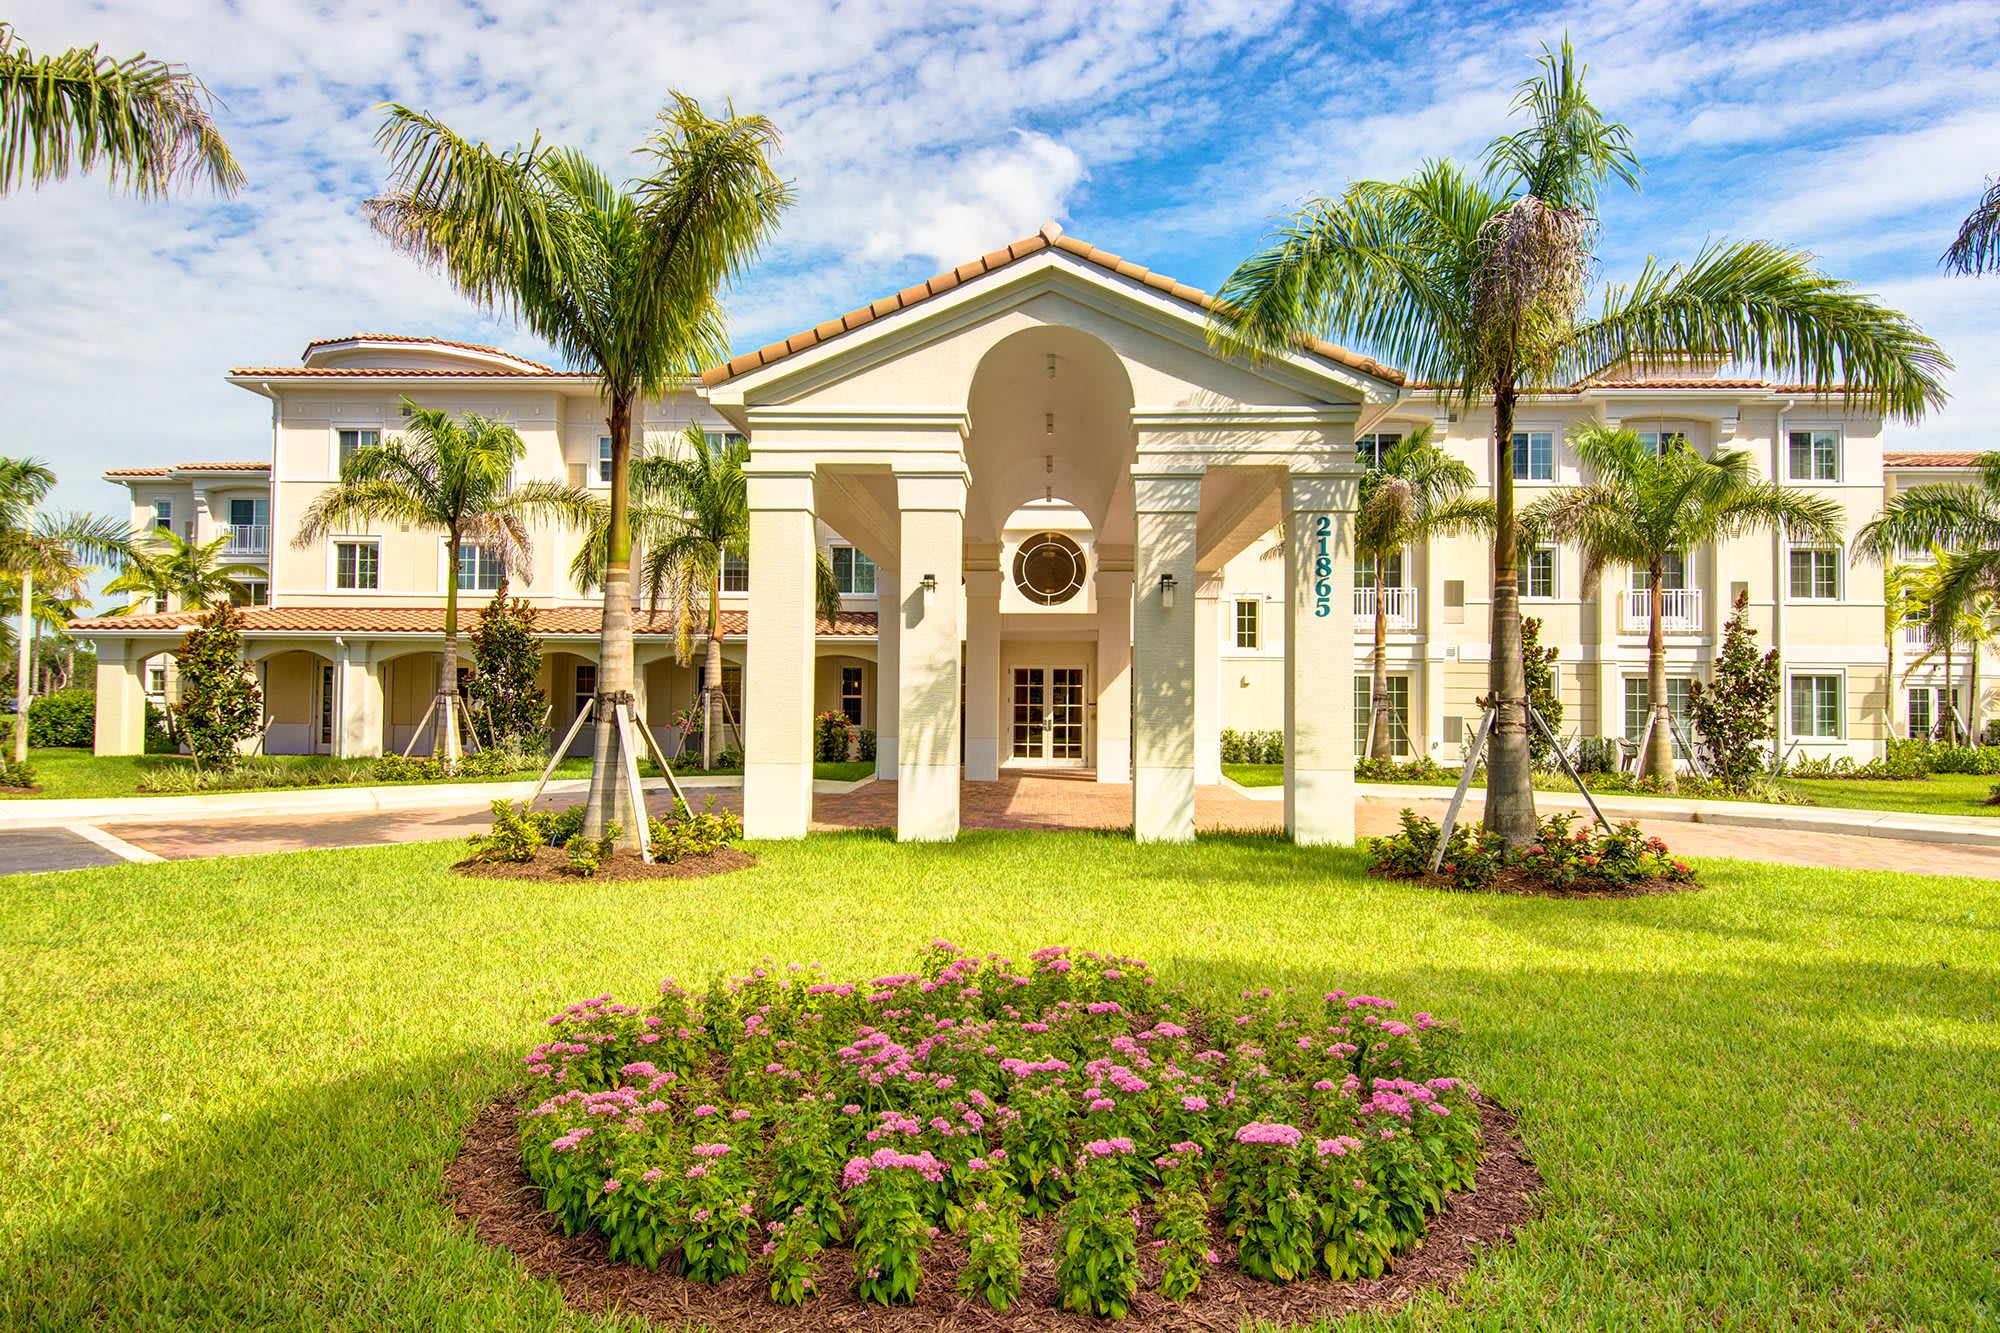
[[1368, 809, 1698, 897]]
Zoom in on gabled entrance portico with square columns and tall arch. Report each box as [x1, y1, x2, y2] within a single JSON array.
[[710, 224, 1400, 843]]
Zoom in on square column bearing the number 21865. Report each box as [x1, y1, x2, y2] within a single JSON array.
[[1284, 472, 1356, 843]]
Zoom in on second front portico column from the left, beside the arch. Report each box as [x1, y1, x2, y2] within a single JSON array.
[[896, 470, 966, 843]]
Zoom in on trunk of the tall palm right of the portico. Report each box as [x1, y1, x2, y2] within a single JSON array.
[[1484, 380, 1536, 847]]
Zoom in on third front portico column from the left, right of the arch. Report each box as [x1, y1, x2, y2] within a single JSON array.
[[1132, 472, 1202, 843]]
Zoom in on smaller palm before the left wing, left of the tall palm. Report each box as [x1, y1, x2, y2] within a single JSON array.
[[292, 398, 598, 763]]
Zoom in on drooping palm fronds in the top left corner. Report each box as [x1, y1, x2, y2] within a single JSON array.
[[0, 24, 244, 198]]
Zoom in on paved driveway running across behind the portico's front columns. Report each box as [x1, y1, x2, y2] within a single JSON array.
[[0, 773, 2000, 879]]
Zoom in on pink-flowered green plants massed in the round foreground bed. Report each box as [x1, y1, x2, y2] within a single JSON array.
[[508, 945, 1482, 1321]]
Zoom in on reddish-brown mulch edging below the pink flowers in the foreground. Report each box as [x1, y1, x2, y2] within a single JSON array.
[[444, 1095, 1542, 1333]]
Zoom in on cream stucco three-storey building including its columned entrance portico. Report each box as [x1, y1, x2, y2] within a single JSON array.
[[70, 226, 1960, 841]]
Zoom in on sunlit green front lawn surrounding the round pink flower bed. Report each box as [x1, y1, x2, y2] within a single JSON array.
[[0, 833, 2000, 1331]]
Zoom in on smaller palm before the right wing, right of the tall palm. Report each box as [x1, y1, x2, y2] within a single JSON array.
[[1522, 424, 1840, 791]]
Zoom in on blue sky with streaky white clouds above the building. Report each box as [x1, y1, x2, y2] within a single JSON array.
[[0, 0, 2000, 524]]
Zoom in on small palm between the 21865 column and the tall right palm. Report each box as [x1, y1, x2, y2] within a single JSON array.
[[1354, 426, 1494, 759]]
